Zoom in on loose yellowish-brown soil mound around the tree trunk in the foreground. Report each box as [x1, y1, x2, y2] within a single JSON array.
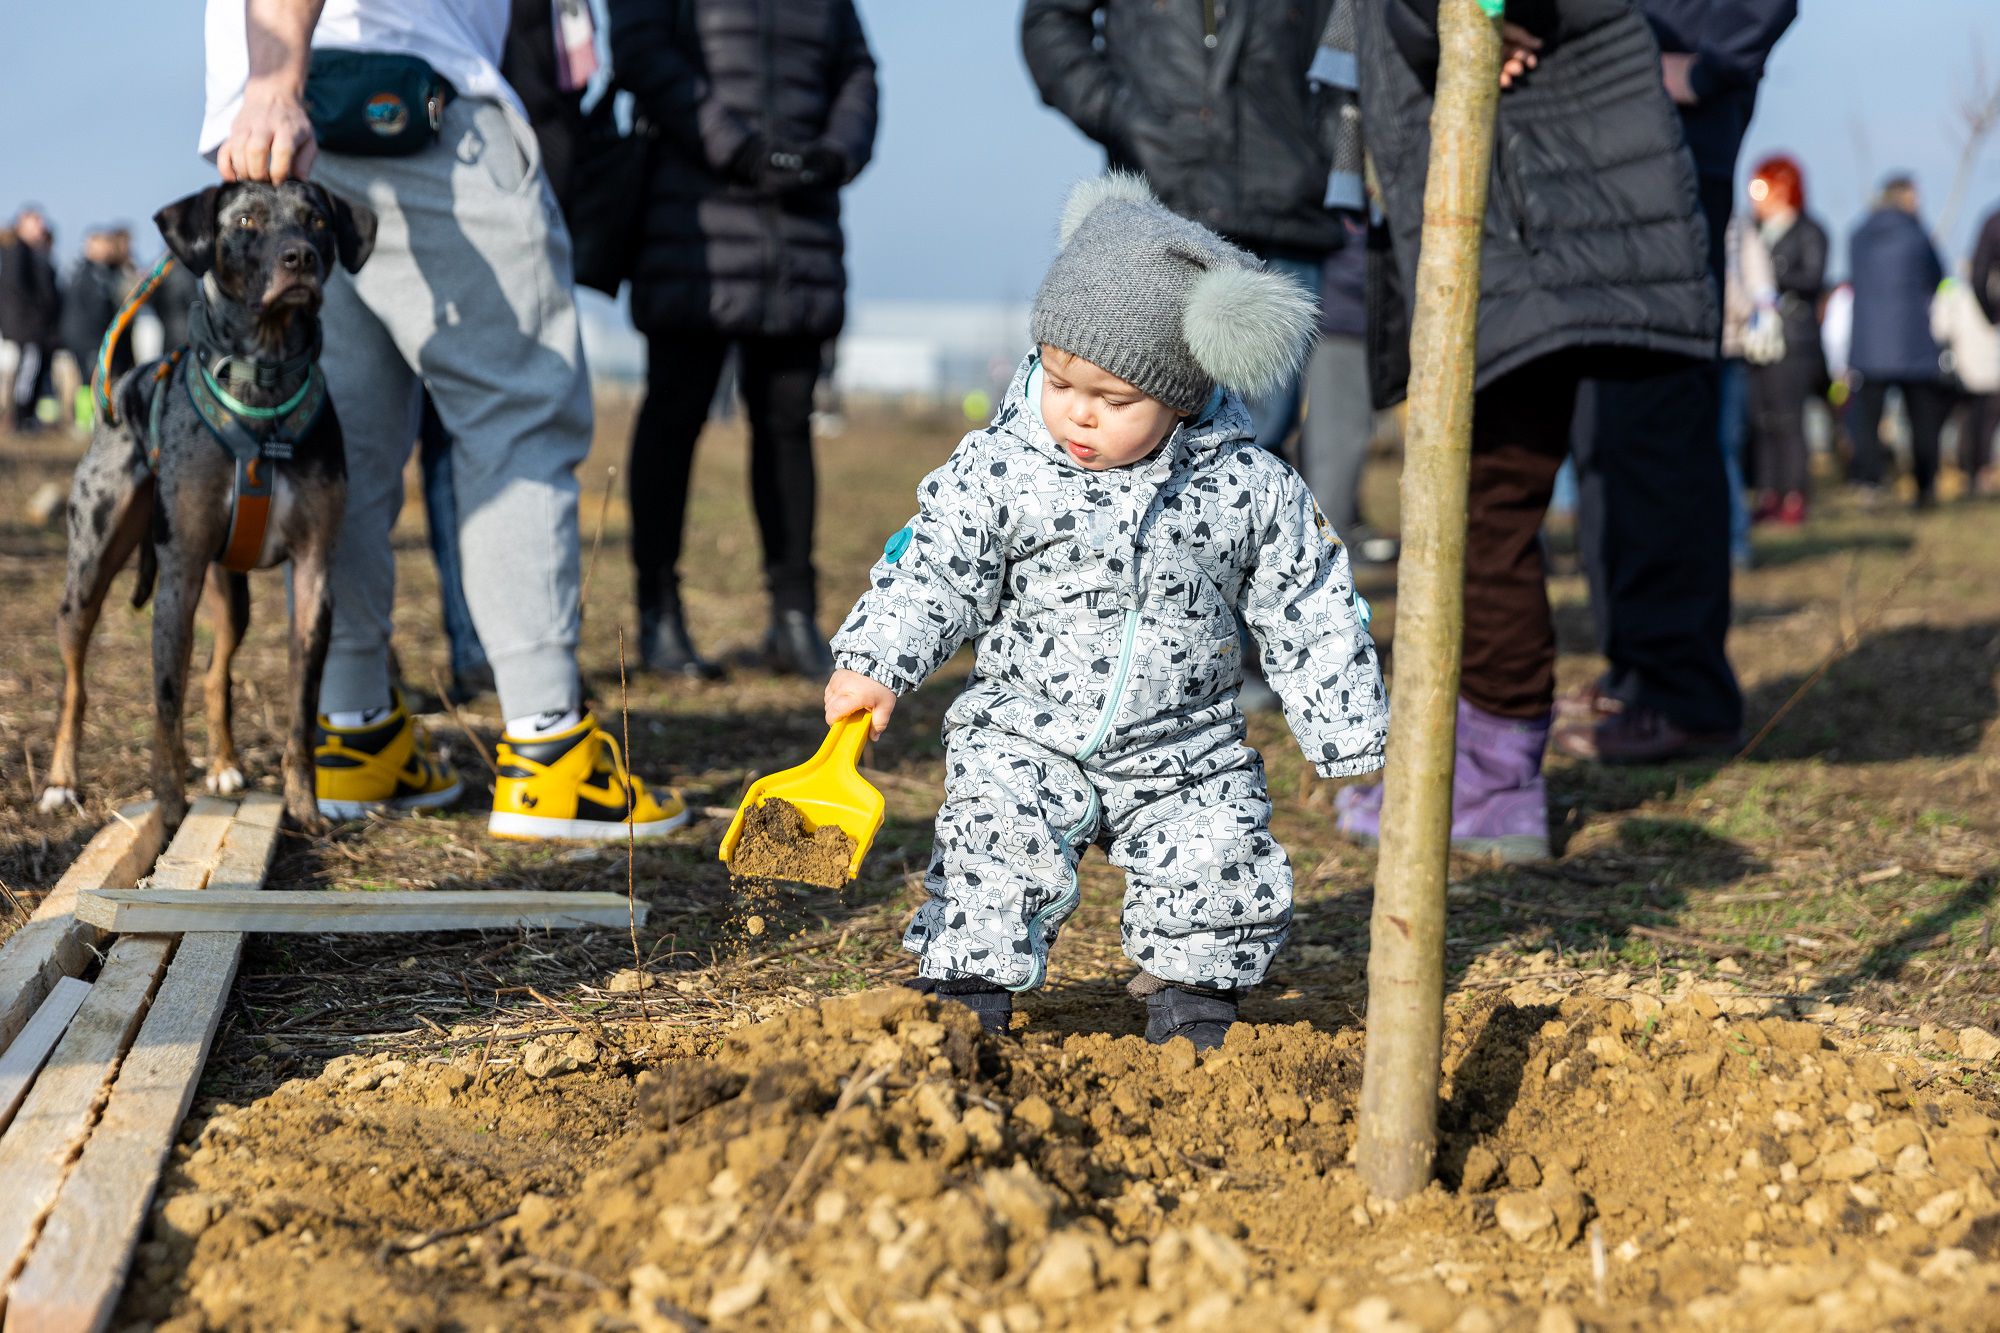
[[125, 985, 2000, 1333]]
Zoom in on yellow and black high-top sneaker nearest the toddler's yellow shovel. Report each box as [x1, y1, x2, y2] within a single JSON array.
[[486, 713, 688, 841]]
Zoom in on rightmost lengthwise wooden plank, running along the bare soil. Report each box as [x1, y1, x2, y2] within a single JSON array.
[[6, 793, 284, 1333]]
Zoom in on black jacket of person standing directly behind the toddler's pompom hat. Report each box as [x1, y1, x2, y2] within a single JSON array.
[[1020, 0, 1344, 260]]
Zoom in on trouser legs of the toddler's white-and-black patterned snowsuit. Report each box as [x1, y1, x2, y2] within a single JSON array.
[[902, 727, 1292, 991]]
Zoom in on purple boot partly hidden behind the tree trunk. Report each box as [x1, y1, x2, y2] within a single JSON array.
[[1334, 699, 1548, 861]]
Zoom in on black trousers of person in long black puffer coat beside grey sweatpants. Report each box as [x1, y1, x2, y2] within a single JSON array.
[[628, 334, 822, 614]]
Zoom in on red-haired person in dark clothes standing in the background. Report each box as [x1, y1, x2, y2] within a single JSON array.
[[1750, 154, 1826, 524]]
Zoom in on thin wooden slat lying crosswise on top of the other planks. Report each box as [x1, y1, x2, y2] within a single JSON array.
[[76, 889, 646, 935]]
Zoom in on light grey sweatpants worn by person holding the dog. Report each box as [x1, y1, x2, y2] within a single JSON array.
[[312, 98, 590, 717]]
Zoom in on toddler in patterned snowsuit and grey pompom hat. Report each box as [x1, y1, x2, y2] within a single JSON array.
[[826, 174, 1388, 1047]]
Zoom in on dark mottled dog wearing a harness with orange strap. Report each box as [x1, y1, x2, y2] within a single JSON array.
[[42, 180, 376, 831]]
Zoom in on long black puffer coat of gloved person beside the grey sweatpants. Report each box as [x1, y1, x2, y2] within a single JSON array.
[[608, 0, 876, 338]]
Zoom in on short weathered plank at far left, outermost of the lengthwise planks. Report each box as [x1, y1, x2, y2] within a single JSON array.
[[0, 801, 160, 1051]]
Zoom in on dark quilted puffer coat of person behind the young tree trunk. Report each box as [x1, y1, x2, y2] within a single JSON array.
[[1360, 0, 1722, 398]]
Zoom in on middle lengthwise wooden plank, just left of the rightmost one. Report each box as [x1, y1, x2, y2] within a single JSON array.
[[0, 797, 236, 1304]]
